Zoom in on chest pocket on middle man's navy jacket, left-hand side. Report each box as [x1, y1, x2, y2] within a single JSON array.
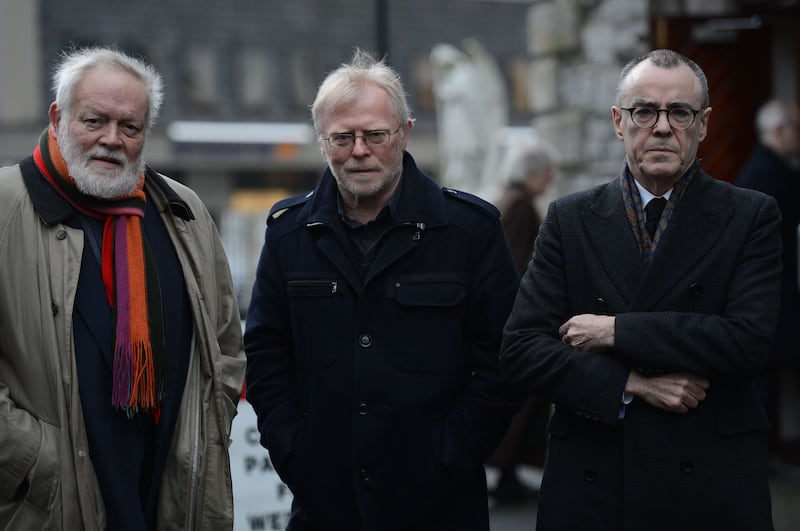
[[286, 279, 344, 369]]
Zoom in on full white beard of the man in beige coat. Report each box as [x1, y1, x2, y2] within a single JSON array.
[[57, 127, 144, 199]]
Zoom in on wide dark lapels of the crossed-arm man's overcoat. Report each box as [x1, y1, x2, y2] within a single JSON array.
[[582, 169, 733, 309]]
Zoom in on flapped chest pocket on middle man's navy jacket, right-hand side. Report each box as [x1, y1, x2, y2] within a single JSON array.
[[390, 279, 466, 373]]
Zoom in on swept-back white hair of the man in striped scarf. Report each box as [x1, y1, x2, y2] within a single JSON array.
[[52, 46, 164, 127]]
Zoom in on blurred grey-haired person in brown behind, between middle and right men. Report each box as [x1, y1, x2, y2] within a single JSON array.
[[486, 139, 553, 505]]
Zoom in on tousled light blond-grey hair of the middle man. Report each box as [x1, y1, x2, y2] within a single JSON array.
[[311, 48, 412, 135]]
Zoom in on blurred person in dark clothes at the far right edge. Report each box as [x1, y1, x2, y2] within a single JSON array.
[[734, 99, 800, 464]]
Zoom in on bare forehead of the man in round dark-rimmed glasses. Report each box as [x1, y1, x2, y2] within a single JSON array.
[[621, 59, 702, 109]]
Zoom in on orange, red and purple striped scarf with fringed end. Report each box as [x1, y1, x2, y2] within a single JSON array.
[[33, 129, 165, 422]]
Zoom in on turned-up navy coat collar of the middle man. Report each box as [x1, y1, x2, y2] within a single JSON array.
[[297, 152, 447, 231]]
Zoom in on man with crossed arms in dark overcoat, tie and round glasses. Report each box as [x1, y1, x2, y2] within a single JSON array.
[[500, 50, 781, 531]]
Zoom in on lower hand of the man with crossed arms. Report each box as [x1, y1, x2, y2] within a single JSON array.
[[625, 371, 709, 413]]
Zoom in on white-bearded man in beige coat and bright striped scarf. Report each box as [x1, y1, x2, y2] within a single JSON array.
[[0, 48, 245, 531]]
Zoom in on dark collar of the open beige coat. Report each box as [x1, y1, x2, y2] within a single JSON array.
[[19, 157, 195, 225]]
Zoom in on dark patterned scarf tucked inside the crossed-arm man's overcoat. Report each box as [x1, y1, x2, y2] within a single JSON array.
[[620, 161, 700, 264]]
